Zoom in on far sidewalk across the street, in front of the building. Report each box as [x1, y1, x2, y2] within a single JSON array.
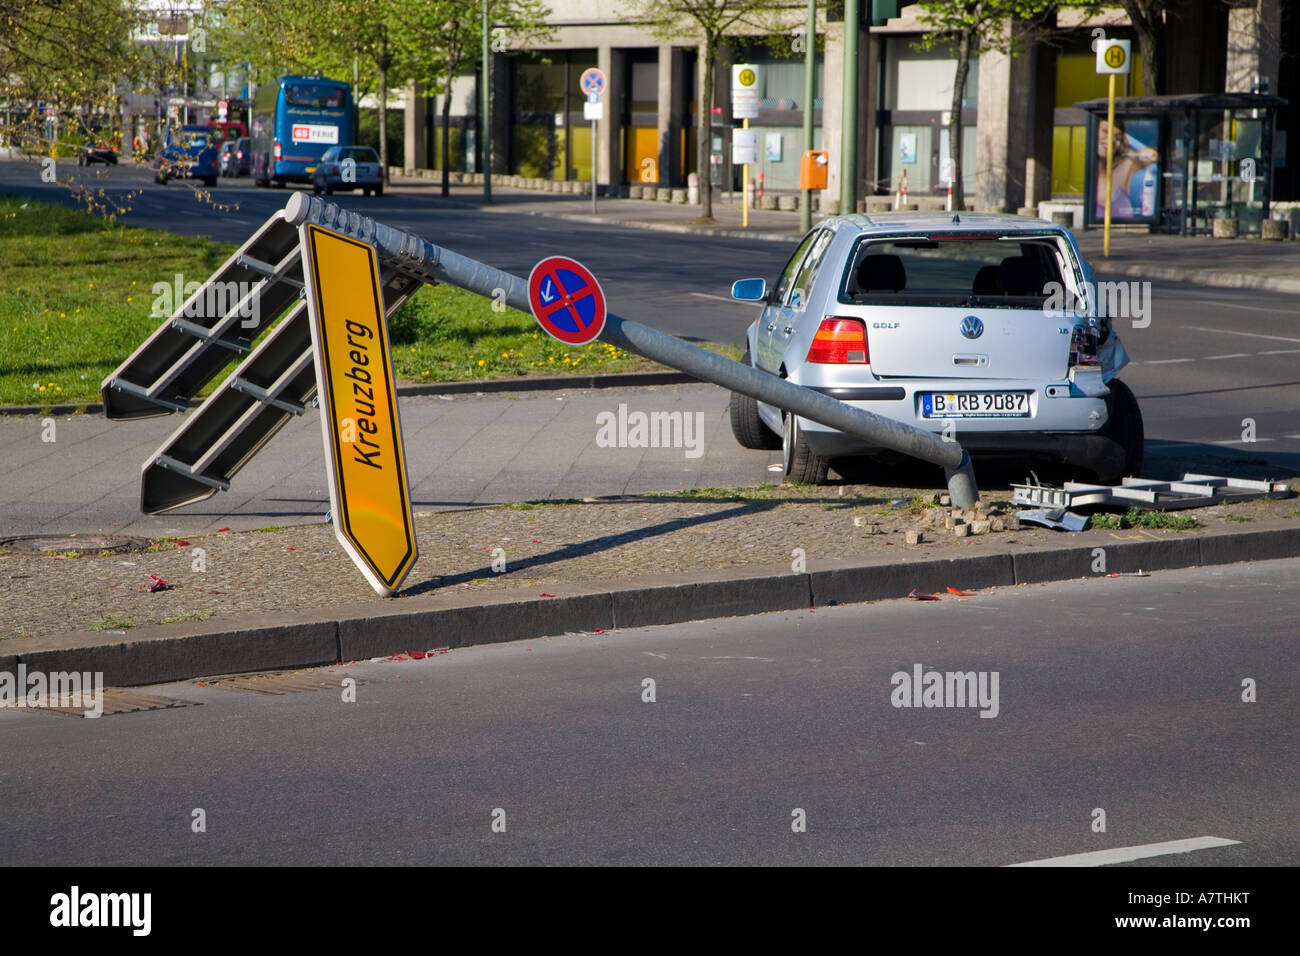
[[382, 176, 1300, 293]]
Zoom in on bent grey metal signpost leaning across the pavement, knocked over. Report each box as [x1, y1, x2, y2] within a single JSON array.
[[285, 193, 979, 507]]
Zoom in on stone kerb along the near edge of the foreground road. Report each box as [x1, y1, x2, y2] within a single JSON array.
[[10, 527, 1300, 685]]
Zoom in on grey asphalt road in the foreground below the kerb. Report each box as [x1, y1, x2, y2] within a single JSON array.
[[0, 559, 1300, 868]]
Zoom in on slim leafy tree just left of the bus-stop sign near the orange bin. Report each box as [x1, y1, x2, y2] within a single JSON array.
[[623, 0, 785, 220]]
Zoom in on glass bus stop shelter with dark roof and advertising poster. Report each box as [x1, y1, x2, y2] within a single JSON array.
[[1075, 92, 1287, 235]]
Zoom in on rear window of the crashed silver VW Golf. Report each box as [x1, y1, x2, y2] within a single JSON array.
[[840, 235, 1061, 308]]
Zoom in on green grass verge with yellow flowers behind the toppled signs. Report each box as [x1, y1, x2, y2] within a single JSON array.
[[0, 195, 702, 406]]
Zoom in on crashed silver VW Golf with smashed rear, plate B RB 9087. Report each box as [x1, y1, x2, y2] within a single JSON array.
[[731, 212, 1143, 484]]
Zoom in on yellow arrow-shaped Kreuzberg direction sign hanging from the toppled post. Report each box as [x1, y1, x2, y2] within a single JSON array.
[[300, 224, 419, 594]]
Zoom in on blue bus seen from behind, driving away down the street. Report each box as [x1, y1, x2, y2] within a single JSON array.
[[250, 74, 356, 186]]
